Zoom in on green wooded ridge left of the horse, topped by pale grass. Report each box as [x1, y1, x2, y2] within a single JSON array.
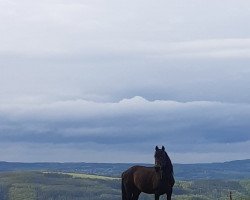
[[0, 172, 120, 200]]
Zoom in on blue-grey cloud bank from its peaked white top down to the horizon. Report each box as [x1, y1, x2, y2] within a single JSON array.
[[0, 97, 250, 163]]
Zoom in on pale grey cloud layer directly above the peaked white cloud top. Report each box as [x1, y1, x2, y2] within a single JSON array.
[[0, 59, 250, 103]]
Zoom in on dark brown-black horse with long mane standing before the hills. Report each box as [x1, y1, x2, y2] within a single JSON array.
[[122, 146, 175, 200]]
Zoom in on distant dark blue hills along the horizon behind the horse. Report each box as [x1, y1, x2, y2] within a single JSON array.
[[0, 159, 250, 180]]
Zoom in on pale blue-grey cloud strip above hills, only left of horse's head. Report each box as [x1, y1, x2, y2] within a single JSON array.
[[0, 142, 154, 163]]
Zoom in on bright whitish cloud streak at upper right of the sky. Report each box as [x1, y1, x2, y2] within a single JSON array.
[[151, 38, 250, 59]]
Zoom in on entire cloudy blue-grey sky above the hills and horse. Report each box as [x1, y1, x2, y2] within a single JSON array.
[[0, 0, 250, 163]]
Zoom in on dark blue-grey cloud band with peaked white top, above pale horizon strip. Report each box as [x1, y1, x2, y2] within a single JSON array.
[[0, 97, 250, 162]]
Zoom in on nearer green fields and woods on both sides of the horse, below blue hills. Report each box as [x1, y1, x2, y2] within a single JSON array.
[[0, 171, 250, 200]]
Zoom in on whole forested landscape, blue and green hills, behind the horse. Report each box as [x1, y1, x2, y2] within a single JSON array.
[[0, 160, 250, 200]]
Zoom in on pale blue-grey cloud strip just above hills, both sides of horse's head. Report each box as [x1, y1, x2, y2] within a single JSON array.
[[0, 141, 250, 163]]
